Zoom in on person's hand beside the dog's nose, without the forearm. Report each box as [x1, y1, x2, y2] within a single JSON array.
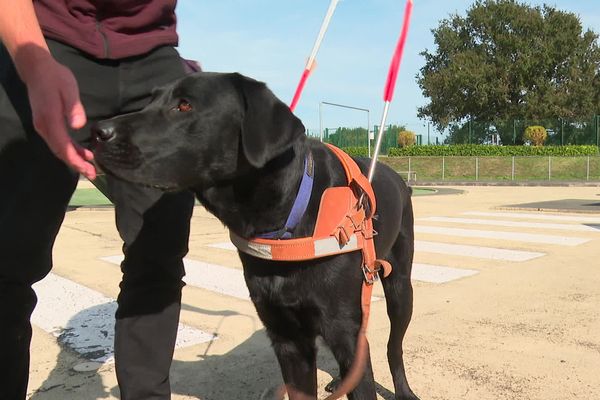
[[21, 53, 96, 180]]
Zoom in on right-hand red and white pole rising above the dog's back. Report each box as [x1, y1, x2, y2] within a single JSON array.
[[368, 0, 413, 182]]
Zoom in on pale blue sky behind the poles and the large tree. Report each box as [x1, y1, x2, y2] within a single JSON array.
[[177, 0, 600, 143]]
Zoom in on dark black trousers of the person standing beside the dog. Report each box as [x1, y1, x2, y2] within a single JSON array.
[[0, 41, 194, 400]]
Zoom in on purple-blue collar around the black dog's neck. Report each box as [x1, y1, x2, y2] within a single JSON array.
[[255, 150, 315, 239]]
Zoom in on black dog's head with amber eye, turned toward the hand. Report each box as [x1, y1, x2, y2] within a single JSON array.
[[92, 72, 305, 190]]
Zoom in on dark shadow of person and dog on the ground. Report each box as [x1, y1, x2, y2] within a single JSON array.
[[29, 305, 394, 400]]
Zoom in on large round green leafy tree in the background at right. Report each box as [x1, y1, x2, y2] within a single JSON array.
[[417, 0, 600, 135]]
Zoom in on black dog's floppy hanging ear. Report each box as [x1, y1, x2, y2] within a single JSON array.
[[235, 74, 305, 168]]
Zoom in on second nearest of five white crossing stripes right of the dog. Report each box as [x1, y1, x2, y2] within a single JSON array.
[[415, 240, 546, 262]]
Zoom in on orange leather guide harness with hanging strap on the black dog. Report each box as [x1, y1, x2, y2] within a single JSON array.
[[230, 144, 392, 399]]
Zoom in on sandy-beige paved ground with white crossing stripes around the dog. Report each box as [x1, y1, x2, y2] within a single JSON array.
[[29, 186, 600, 400]]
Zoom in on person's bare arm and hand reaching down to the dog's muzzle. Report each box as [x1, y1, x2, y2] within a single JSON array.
[[0, 0, 96, 179]]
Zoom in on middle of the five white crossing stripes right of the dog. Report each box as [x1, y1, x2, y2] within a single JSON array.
[[415, 225, 590, 246]]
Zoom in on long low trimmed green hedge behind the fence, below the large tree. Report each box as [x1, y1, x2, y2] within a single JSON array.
[[386, 144, 600, 157]]
